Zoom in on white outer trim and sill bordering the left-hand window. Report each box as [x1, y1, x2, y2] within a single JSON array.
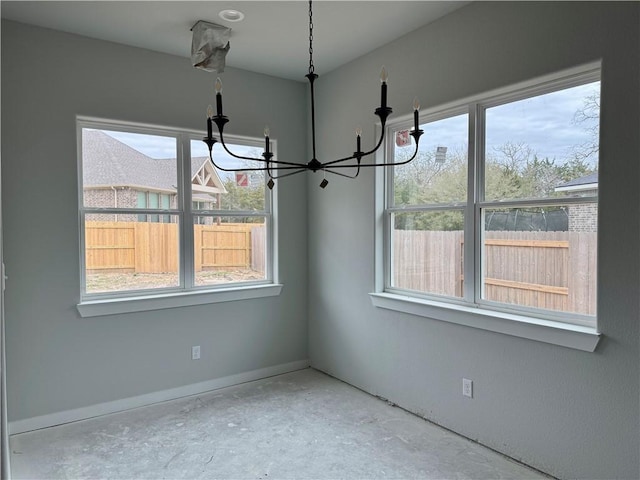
[[76, 116, 283, 317]]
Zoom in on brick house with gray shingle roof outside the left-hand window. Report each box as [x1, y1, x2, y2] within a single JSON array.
[[82, 129, 227, 223]]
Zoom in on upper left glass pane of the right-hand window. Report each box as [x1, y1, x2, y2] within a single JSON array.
[[393, 114, 469, 205]]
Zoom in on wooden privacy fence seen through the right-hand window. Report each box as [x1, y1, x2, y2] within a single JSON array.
[[393, 230, 597, 315]]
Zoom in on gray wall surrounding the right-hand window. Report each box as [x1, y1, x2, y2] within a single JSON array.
[[309, 2, 640, 478]]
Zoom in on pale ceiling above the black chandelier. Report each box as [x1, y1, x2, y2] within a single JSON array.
[[0, 0, 469, 81]]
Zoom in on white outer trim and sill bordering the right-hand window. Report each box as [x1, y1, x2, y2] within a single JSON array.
[[370, 62, 602, 352]]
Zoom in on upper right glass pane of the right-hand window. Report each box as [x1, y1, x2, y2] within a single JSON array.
[[485, 82, 600, 200]]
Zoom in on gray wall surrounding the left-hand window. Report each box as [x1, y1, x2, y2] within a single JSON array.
[[2, 21, 308, 421]]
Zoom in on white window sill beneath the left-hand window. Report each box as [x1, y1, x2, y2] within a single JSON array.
[[77, 284, 282, 317]]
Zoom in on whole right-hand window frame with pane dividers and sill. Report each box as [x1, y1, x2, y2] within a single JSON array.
[[371, 62, 602, 351]]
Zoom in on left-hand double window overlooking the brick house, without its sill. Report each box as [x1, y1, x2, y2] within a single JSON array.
[[78, 119, 274, 310]]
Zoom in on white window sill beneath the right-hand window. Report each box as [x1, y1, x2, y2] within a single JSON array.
[[370, 293, 600, 352]]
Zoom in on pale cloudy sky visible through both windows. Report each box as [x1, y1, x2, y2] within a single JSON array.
[[107, 82, 599, 172]]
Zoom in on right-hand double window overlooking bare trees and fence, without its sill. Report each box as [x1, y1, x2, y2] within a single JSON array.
[[374, 68, 600, 334]]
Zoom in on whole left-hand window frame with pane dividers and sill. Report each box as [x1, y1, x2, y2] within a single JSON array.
[[76, 116, 282, 317]]
